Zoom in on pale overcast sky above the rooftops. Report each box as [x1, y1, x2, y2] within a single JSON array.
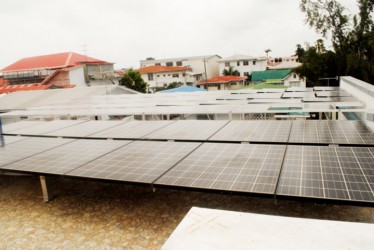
[[0, 0, 358, 68]]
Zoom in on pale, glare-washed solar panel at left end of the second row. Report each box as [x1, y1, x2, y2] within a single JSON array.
[[9, 120, 85, 135]]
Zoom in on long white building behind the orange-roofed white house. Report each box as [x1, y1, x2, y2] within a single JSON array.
[[140, 55, 221, 85]]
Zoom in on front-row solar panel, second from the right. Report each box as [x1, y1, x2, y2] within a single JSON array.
[[155, 143, 286, 194]]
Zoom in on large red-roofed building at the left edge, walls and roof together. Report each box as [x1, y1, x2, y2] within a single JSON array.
[[0, 52, 114, 93]]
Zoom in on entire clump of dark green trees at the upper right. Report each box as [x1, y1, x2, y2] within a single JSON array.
[[295, 0, 374, 84]]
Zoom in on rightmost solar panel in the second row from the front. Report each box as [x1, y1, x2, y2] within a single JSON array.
[[289, 120, 374, 145]]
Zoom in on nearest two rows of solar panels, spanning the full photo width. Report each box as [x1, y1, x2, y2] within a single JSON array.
[[0, 121, 374, 203]]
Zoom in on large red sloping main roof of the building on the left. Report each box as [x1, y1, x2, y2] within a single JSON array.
[[1, 52, 112, 72]]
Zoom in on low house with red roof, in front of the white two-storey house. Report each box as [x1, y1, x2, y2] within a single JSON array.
[[197, 76, 246, 90]]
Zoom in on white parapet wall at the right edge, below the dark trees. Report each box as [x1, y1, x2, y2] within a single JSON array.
[[340, 76, 374, 132]]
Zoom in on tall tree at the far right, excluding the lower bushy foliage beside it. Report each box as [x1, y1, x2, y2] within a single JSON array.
[[300, 0, 374, 84]]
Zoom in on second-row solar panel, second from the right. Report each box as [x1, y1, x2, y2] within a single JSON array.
[[209, 120, 292, 142]]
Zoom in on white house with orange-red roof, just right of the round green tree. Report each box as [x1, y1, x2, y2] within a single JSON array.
[[138, 66, 193, 91]]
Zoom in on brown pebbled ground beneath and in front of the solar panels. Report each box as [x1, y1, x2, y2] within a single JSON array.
[[0, 175, 374, 249]]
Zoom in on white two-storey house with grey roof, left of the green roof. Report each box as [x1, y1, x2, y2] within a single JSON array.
[[219, 55, 267, 77]]
